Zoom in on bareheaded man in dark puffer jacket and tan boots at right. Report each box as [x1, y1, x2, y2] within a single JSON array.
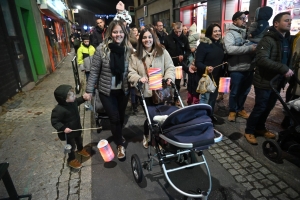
[[245, 12, 293, 144]]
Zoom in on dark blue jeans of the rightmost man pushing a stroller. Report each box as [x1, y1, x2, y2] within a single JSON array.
[[245, 87, 280, 134]]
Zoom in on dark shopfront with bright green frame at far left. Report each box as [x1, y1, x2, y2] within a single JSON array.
[[0, 0, 50, 105]]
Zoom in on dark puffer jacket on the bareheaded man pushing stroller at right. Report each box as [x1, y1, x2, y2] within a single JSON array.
[[253, 27, 292, 89]]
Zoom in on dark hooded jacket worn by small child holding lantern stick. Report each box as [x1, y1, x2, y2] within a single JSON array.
[[51, 85, 85, 138]]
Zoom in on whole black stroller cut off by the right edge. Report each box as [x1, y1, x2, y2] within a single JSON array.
[[262, 75, 300, 163]]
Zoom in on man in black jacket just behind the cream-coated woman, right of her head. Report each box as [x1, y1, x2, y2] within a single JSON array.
[[164, 22, 191, 105]]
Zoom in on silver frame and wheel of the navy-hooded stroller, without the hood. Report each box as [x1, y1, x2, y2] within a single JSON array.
[[131, 83, 223, 200]]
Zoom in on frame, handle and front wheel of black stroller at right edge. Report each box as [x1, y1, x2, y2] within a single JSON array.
[[262, 74, 300, 163]]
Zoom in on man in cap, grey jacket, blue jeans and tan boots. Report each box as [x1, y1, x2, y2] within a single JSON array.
[[224, 11, 256, 121]]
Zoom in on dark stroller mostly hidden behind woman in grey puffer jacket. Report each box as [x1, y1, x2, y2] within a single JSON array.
[[92, 89, 108, 133]]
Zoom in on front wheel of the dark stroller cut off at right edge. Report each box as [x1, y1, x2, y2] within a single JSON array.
[[262, 140, 282, 163]]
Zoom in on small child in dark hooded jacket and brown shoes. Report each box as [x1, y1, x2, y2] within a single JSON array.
[[51, 85, 90, 169]]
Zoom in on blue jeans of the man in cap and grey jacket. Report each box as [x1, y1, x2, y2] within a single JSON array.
[[229, 71, 253, 112]]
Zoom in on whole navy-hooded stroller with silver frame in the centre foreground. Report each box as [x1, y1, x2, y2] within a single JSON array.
[[131, 83, 222, 200]]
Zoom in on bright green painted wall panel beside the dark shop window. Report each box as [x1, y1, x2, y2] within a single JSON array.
[[15, 0, 47, 81]]
